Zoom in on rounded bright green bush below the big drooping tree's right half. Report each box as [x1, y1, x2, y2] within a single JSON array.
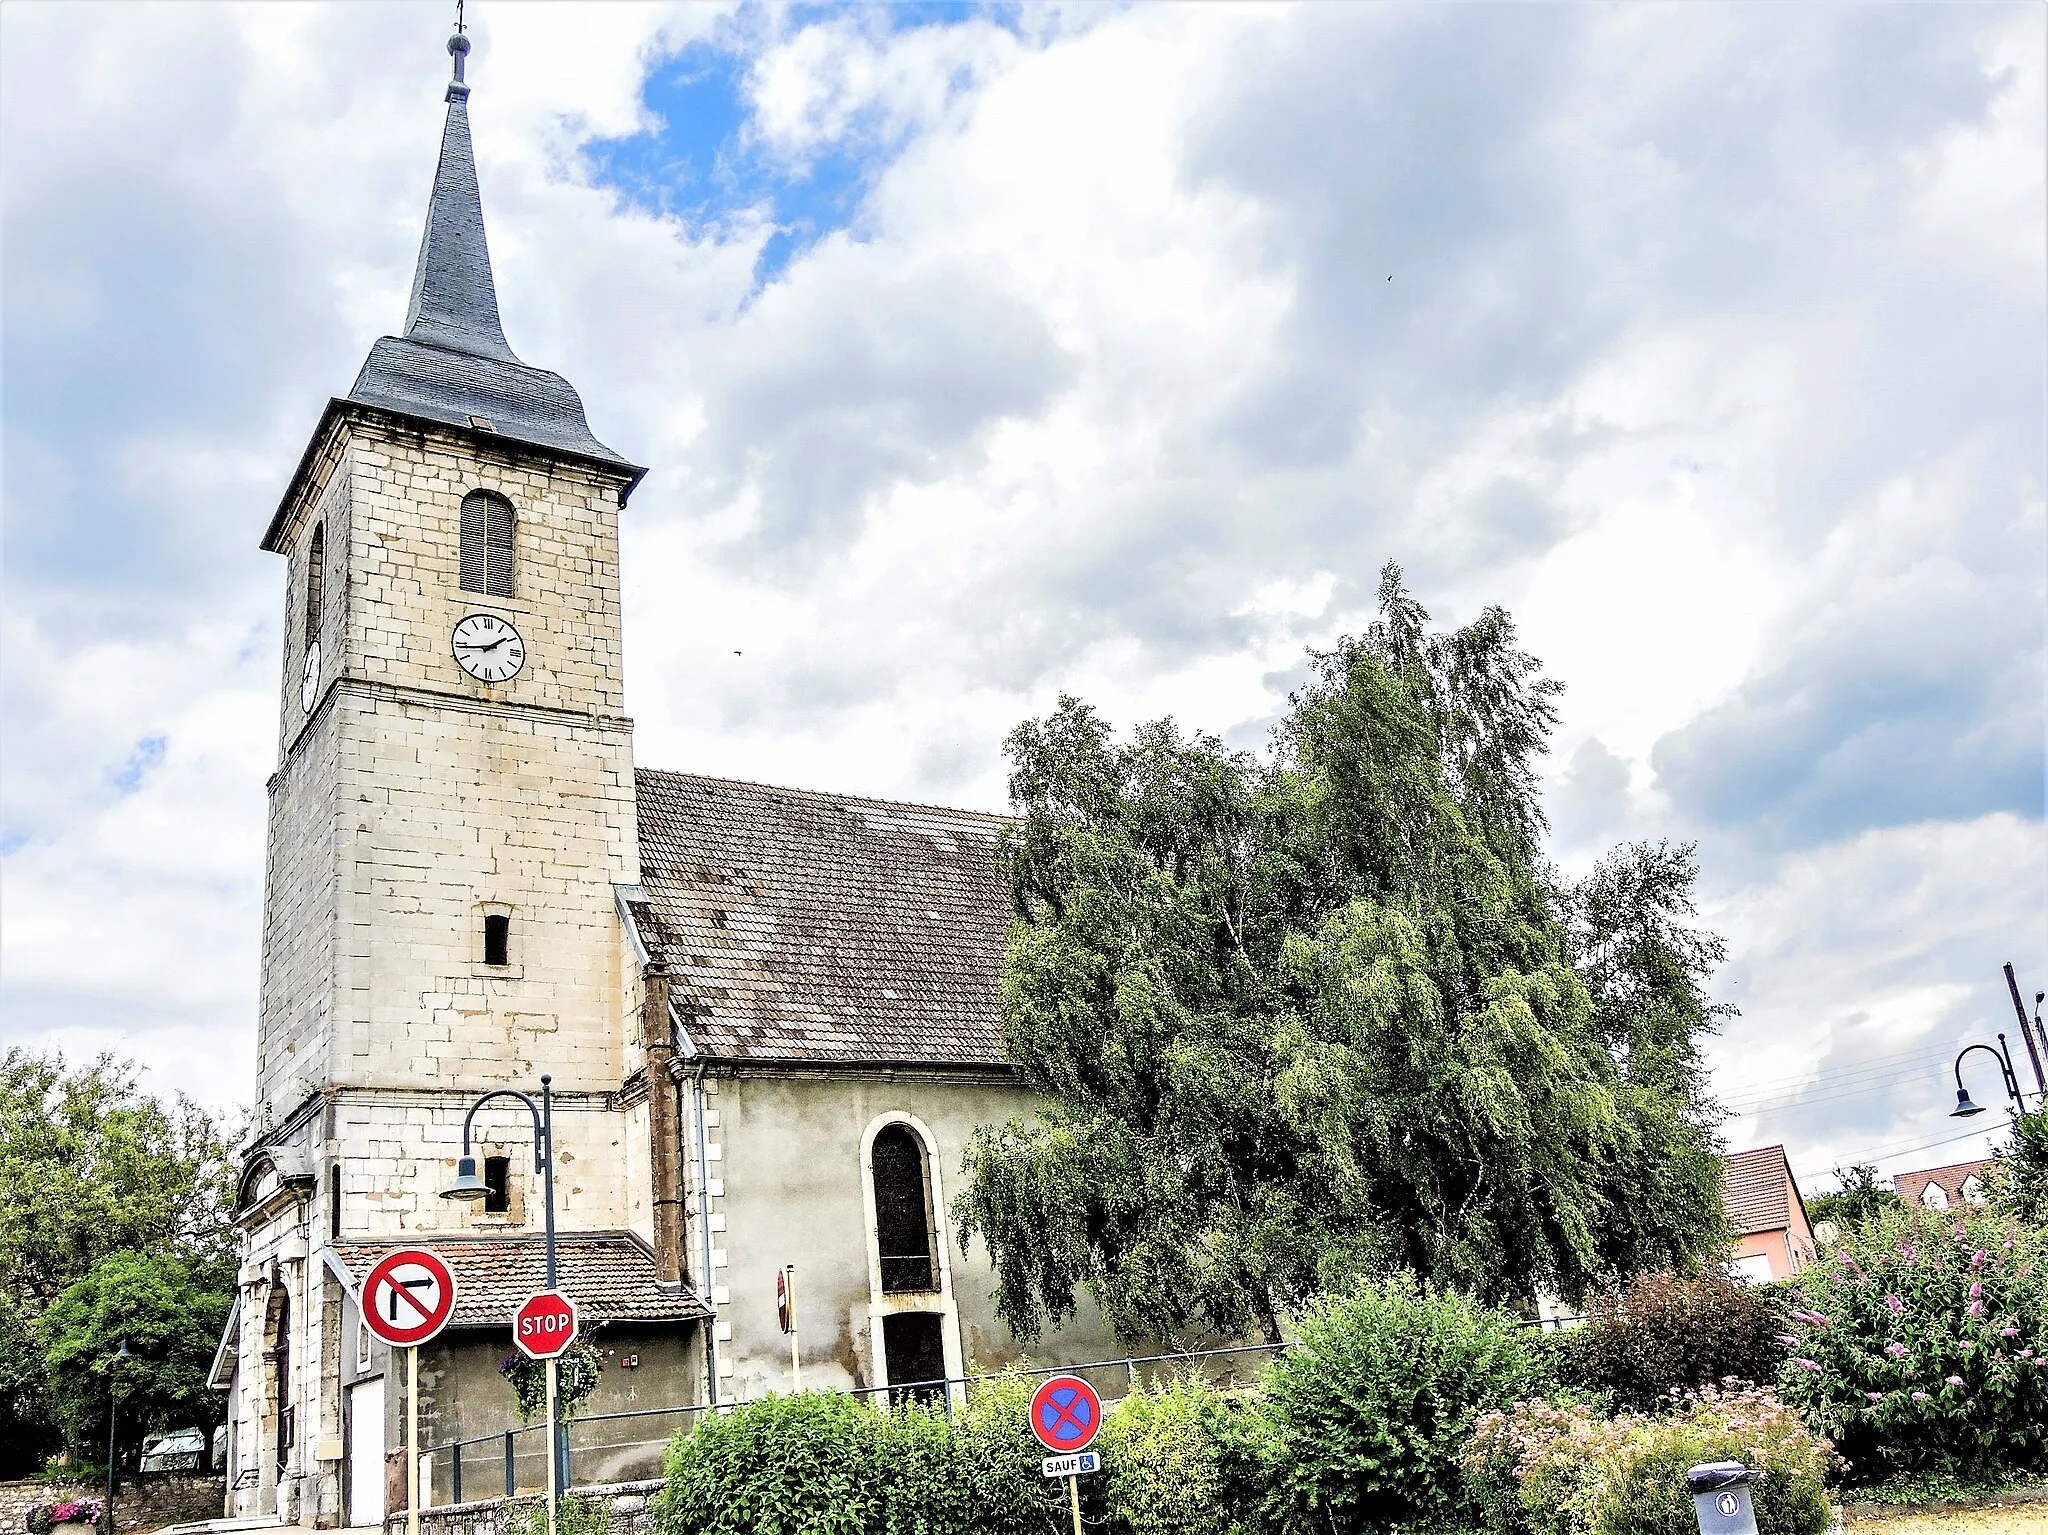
[[1266, 1273, 1538, 1533]]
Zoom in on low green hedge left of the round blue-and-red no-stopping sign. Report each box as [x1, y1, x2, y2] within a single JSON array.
[[653, 1382, 1065, 1535]]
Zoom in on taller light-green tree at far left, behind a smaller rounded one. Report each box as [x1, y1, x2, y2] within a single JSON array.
[[0, 1050, 236, 1474]]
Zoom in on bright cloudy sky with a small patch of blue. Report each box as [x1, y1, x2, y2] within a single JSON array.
[[0, 0, 2048, 1193]]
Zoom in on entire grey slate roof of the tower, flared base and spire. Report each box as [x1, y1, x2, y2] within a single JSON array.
[[348, 37, 633, 469]]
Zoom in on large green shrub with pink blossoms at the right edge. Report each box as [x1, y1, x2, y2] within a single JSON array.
[[1780, 1210, 2048, 1482]]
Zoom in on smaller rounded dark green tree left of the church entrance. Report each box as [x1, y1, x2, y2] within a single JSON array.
[[35, 1253, 233, 1457]]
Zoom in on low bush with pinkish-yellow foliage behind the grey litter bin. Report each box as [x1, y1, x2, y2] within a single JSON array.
[[1462, 1386, 1835, 1535]]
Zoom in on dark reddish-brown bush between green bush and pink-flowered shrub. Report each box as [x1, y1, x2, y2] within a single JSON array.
[[1548, 1273, 1786, 1412]]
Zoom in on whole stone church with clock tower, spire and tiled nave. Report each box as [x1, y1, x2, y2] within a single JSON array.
[[213, 35, 1120, 1527]]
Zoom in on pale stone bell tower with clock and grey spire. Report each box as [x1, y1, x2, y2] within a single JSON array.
[[256, 24, 645, 1236]]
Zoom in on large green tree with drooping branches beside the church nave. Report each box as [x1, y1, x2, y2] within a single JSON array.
[[954, 565, 1724, 1339]]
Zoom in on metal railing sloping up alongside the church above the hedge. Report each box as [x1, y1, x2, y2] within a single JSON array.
[[420, 1316, 1585, 1506]]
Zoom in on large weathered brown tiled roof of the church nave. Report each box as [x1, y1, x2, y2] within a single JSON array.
[[631, 770, 1010, 1066]]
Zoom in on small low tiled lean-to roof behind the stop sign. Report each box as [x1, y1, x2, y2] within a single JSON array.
[[334, 1232, 707, 1339]]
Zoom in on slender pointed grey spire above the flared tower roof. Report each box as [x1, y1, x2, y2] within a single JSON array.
[[406, 10, 518, 362]]
